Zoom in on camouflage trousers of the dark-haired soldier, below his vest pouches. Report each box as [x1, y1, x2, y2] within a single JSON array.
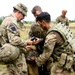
[[51, 62, 75, 75]]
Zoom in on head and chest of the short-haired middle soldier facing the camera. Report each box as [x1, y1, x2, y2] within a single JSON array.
[[29, 6, 45, 38]]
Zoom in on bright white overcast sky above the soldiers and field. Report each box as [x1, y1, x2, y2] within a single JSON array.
[[0, 0, 75, 21]]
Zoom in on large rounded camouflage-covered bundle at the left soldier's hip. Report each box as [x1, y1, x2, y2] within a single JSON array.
[[0, 44, 20, 63]]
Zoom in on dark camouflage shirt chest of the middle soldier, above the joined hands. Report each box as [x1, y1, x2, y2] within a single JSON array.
[[29, 23, 46, 38]]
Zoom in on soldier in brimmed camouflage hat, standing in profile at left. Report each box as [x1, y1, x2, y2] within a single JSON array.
[[0, 3, 33, 75]]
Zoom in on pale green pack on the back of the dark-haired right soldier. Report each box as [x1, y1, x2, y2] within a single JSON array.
[[48, 23, 75, 52]]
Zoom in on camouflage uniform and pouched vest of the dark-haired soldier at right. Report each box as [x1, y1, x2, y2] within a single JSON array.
[[35, 24, 73, 75]]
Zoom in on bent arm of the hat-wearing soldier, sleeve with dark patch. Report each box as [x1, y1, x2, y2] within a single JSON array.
[[7, 24, 31, 46]]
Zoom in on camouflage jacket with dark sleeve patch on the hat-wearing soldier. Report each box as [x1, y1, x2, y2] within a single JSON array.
[[1, 15, 26, 46]]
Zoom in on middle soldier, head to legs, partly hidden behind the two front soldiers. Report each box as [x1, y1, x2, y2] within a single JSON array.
[[27, 6, 46, 75]]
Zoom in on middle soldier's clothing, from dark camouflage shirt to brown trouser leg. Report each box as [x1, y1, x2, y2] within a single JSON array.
[[27, 23, 46, 75]]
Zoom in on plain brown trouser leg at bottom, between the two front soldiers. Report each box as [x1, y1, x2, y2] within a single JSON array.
[[27, 62, 39, 75]]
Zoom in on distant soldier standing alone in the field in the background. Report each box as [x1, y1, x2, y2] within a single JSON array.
[[56, 10, 69, 26]]
